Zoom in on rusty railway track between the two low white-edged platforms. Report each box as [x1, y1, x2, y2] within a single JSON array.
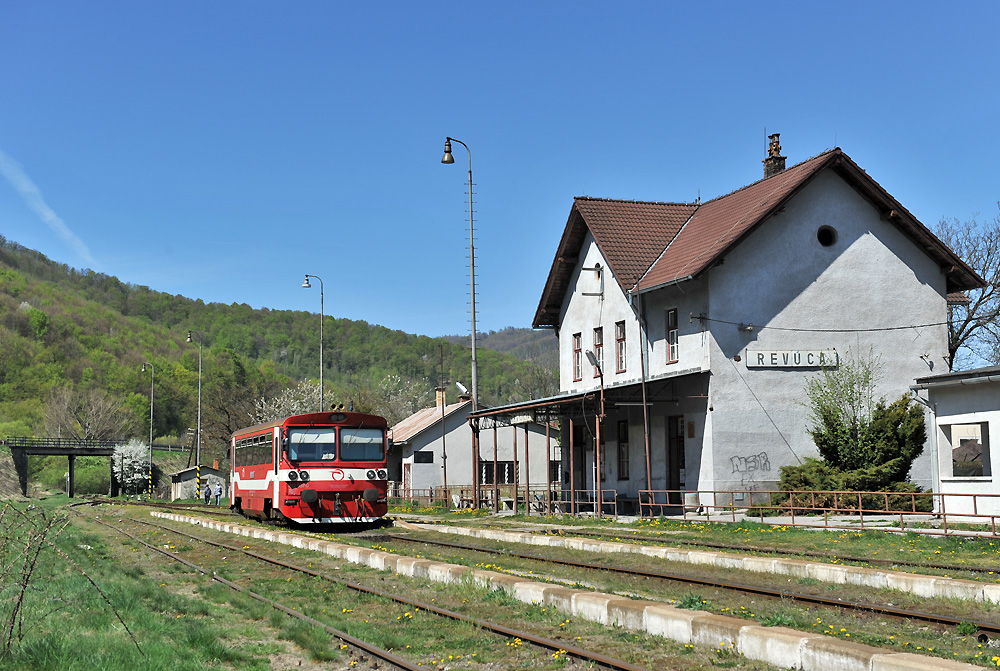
[[385, 534, 1000, 636]]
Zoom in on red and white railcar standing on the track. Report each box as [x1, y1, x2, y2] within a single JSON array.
[[229, 412, 388, 524]]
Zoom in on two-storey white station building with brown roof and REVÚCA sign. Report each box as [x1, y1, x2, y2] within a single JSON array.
[[472, 135, 983, 504]]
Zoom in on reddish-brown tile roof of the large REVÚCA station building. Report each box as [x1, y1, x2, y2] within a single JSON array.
[[533, 148, 985, 328]]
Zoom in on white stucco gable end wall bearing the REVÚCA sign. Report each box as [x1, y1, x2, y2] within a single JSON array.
[[704, 171, 947, 489]]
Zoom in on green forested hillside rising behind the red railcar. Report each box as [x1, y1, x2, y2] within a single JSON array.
[[0, 236, 557, 468]]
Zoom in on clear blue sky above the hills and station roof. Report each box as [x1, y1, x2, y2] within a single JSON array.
[[0, 0, 1000, 335]]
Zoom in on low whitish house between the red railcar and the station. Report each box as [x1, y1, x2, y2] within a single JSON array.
[[390, 390, 559, 504]]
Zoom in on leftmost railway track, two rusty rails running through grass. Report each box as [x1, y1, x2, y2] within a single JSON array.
[[95, 519, 649, 671]]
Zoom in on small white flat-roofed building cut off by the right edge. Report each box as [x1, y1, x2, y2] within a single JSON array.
[[912, 366, 1000, 515]]
